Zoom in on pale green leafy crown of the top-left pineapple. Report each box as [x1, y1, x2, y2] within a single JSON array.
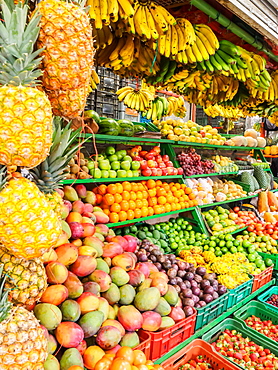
[[0, 0, 43, 86]]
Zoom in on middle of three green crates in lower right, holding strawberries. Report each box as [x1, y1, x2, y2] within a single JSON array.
[[234, 301, 278, 345]]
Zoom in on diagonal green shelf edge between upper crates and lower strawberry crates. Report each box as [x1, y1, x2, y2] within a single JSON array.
[[155, 279, 275, 364]]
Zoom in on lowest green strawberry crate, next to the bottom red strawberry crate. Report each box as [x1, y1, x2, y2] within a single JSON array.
[[202, 319, 278, 369]]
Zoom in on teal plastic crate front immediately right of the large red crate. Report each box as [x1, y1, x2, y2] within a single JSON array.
[[195, 292, 229, 330]]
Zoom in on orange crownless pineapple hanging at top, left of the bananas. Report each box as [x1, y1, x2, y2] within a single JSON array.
[[37, 0, 95, 118]]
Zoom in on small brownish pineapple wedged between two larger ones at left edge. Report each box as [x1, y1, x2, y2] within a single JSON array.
[[0, 245, 47, 306]]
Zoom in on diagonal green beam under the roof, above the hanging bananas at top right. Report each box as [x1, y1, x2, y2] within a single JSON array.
[[190, 0, 278, 62]]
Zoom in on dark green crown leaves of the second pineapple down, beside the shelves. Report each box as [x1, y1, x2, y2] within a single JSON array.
[[30, 117, 86, 194]]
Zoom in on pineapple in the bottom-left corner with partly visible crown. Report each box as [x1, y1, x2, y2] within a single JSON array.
[[0, 266, 47, 370]]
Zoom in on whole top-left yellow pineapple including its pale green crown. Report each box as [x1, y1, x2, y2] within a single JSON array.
[[0, 0, 52, 168]]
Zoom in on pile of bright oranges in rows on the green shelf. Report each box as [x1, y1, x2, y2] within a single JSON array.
[[93, 180, 198, 223]]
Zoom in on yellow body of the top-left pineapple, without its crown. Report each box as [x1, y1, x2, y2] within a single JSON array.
[[0, 86, 52, 168]]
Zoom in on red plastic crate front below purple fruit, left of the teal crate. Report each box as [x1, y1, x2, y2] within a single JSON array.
[[139, 308, 197, 361]]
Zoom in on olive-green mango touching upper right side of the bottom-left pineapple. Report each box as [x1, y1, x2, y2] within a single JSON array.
[[34, 303, 62, 330]]
